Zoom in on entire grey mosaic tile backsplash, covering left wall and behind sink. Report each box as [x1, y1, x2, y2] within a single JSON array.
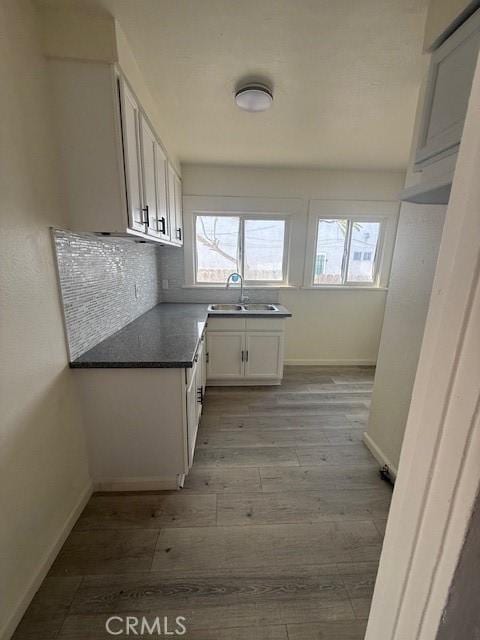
[[53, 230, 278, 360]]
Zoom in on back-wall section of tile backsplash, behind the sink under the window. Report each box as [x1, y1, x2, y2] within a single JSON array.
[[157, 247, 279, 302]]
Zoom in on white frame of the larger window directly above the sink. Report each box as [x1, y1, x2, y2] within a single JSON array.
[[192, 211, 290, 288]]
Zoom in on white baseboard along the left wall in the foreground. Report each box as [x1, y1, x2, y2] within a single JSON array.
[[0, 483, 93, 640]]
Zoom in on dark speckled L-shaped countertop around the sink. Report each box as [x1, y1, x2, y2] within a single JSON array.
[[70, 303, 291, 369]]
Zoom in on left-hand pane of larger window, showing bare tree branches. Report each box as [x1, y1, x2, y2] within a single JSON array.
[[195, 216, 240, 283]]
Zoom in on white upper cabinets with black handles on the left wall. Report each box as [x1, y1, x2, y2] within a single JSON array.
[[49, 60, 183, 246]]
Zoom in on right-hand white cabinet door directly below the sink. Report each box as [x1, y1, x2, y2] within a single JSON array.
[[245, 331, 283, 379]]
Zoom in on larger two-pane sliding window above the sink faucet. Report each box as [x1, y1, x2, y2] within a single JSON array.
[[194, 214, 287, 284]]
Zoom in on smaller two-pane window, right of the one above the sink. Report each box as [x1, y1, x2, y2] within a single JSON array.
[[313, 217, 382, 286]]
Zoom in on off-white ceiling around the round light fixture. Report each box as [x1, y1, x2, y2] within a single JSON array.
[[36, 0, 427, 170]]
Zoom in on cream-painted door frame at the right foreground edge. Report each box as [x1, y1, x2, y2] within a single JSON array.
[[365, 53, 480, 640]]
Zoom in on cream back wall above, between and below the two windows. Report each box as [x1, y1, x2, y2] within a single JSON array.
[[182, 164, 405, 364]]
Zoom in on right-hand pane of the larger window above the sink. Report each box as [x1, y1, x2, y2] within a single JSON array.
[[244, 219, 285, 282]]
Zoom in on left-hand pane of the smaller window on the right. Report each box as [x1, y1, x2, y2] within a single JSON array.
[[313, 219, 347, 284]]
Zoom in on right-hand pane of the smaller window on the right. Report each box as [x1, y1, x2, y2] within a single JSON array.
[[347, 220, 380, 283]]
